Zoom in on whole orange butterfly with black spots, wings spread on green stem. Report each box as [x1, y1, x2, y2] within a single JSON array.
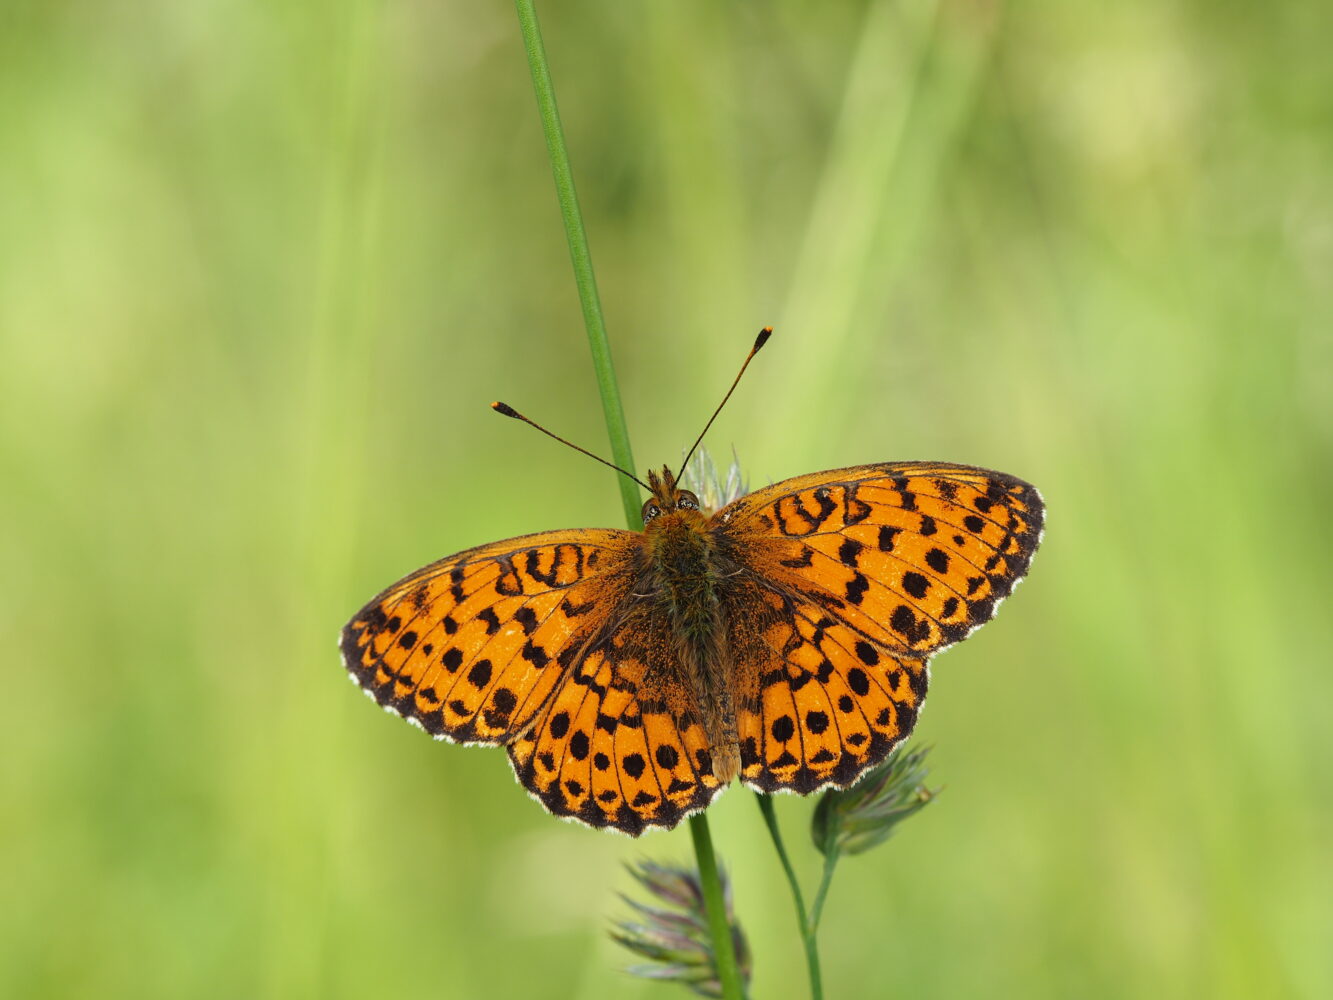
[[341, 329, 1042, 835]]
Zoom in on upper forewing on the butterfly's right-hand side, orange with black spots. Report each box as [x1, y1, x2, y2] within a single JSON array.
[[714, 463, 1042, 659]]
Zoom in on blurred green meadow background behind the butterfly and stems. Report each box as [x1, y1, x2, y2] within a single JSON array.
[[0, 0, 1333, 1000]]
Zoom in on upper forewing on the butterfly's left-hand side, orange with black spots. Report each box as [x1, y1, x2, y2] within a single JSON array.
[[340, 528, 641, 744]]
